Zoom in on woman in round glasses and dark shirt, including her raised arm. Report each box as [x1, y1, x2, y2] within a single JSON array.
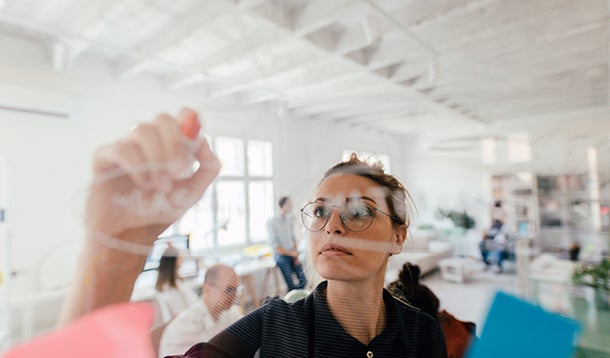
[[62, 111, 447, 358]]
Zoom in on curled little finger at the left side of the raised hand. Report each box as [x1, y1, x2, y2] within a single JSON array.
[[94, 139, 152, 189]]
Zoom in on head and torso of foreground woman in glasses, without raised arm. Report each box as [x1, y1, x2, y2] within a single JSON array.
[[172, 154, 446, 357]]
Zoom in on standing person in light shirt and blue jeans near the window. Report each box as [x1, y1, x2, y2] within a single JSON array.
[[267, 196, 307, 291]]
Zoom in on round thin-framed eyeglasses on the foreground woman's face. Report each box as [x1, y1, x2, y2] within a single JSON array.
[[301, 201, 396, 232]]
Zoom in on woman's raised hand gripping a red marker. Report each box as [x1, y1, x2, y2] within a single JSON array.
[[85, 109, 220, 245]]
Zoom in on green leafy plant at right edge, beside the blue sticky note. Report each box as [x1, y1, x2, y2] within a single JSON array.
[[572, 257, 610, 310]]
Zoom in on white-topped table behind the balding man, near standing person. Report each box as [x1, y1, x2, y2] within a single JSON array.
[[234, 257, 281, 309]]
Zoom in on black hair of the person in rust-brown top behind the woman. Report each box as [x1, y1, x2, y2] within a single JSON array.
[[388, 262, 440, 317]]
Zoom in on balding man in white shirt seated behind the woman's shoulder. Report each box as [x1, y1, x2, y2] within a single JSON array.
[[159, 264, 243, 357]]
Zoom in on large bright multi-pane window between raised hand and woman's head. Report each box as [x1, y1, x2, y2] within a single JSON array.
[[171, 137, 274, 250]]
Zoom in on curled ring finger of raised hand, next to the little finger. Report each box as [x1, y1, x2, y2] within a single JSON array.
[[129, 123, 168, 189]]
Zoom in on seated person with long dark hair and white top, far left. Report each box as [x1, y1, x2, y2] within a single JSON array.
[[155, 246, 199, 323]]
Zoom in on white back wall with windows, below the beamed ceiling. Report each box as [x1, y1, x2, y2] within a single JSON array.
[[0, 33, 402, 295]]
